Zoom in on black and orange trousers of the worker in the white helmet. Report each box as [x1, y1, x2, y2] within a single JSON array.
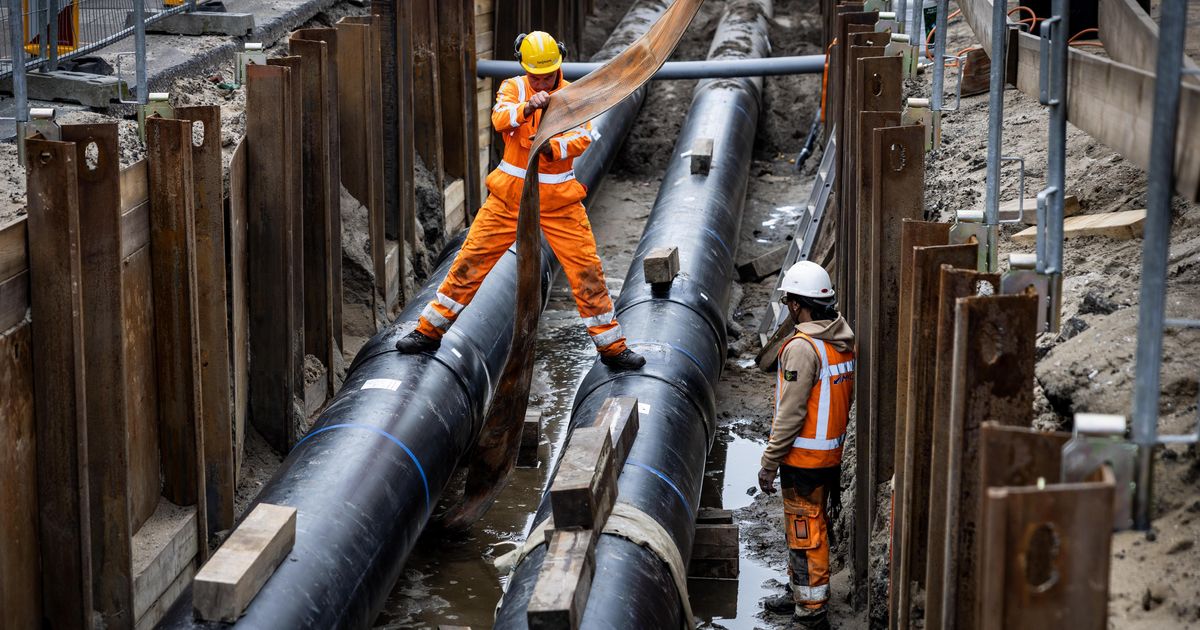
[[779, 466, 838, 612]]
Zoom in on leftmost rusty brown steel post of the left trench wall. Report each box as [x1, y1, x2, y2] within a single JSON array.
[[25, 138, 92, 628]]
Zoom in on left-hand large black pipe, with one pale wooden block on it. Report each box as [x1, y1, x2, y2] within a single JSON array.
[[161, 0, 667, 630]]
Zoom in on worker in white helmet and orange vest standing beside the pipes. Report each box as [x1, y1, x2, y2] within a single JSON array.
[[758, 260, 854, 630]]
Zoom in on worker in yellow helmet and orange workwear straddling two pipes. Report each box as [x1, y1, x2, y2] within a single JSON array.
[[396, 31, 646, 370]]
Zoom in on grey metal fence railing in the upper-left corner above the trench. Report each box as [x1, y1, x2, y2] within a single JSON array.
[[0, 0, 196, 78]]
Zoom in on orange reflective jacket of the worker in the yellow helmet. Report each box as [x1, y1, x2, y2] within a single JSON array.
[[487, 76, 593, 210]]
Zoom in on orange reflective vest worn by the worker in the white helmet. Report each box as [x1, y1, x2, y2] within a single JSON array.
[[775, 332, 854, 468]]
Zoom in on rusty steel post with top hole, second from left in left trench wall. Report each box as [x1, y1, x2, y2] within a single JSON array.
[[61, 124, 133, 628]]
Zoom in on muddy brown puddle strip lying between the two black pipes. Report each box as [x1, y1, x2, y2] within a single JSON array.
[[374, 292, 595, 629]]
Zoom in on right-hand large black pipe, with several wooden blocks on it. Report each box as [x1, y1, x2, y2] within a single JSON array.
[[496, 0, 770, 629]]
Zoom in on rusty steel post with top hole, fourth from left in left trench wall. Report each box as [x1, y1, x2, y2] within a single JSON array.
[[175, 106, 236, 532]]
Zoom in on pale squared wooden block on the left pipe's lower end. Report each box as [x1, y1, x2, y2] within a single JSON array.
[[192, 503, 296, 623]]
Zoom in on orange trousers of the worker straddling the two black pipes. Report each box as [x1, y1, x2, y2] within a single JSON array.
[[416, 194, 625, 356]]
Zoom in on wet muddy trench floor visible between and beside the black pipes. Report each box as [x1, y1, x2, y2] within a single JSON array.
[[374, 0, 865, 629]]
